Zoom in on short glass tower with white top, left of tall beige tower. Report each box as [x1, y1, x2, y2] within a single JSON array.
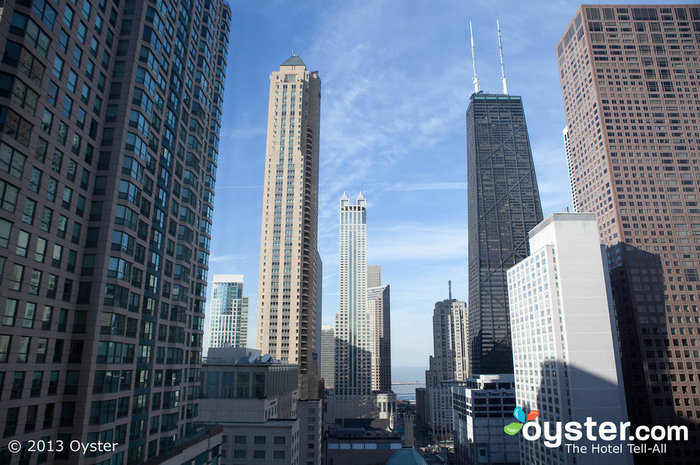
[[209, 274, 248, 348]]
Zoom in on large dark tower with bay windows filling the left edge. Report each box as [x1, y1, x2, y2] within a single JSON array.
[[0, 0, 230, 464]]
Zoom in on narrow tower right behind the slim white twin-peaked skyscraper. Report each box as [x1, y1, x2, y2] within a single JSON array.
[[367, 282, 391, 391]]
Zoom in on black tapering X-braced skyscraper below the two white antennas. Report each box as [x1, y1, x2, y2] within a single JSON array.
[[467, 93, 542, 376]]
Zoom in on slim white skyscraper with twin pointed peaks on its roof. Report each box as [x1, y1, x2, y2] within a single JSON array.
[[335, 193, 372, 398]]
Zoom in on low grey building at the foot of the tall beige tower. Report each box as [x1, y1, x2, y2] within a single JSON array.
[[199, 348, 306, 465]]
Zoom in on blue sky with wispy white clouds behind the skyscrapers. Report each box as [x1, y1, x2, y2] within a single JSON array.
[[205, 0, 676, 367]]
